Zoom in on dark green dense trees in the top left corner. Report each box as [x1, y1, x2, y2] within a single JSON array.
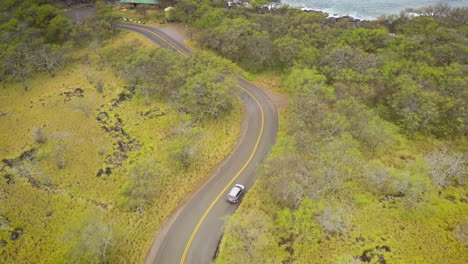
[[0, 0, 122, 90]]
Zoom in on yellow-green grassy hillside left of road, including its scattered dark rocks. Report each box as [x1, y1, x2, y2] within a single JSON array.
[[0, 32, 242, 263]]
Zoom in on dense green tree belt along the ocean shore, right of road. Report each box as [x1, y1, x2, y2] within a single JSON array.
[[179, 1, 468, 137]]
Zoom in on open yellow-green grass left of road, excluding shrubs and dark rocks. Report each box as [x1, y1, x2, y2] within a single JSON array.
[[0, 29, 243, 263]]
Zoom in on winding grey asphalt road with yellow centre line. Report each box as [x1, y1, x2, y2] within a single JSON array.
[[119, 24, 278, 264]]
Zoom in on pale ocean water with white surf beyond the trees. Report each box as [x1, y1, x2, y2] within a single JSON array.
[[282, 0, 468, 20]]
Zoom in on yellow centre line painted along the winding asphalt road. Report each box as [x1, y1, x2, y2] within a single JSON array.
[[120, 24, 265, 264]]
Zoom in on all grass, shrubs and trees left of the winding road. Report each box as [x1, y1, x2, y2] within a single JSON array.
[[0, 0, 242, 263]]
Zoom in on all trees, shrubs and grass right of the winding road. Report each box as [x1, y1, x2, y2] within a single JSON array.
[[165, 0, 468, 264]]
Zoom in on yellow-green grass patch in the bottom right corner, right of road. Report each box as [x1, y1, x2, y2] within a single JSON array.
[[313, 193, 467, 264]]
